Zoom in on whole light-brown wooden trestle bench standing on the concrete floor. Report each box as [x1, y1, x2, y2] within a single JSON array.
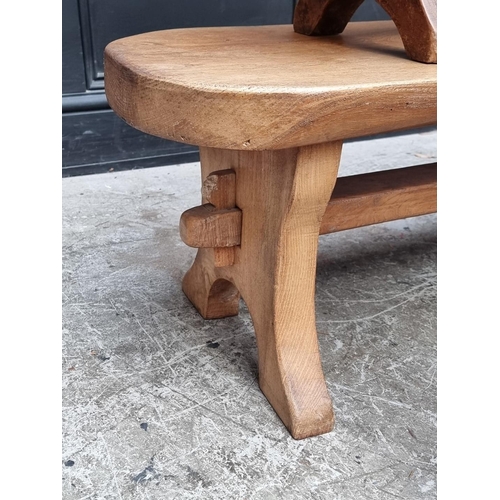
[[105, 7, 436, 439]]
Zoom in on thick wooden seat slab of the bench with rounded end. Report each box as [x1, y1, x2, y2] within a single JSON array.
[[105, 21, 436, 150]]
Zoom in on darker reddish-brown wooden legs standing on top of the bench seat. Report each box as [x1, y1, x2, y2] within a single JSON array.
[[293, 0, 437, 63]]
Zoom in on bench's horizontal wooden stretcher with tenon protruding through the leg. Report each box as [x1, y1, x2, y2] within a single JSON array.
[[180, 163, 437, 243]]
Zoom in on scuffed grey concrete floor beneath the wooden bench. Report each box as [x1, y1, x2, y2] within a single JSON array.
[[62, 131, 436, 500]]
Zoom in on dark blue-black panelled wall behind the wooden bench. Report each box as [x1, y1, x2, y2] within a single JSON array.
[[62, 0, 388, 176]]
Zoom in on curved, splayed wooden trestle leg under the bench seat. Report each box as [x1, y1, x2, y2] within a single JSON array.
[[183, 142, 341, 439]]
